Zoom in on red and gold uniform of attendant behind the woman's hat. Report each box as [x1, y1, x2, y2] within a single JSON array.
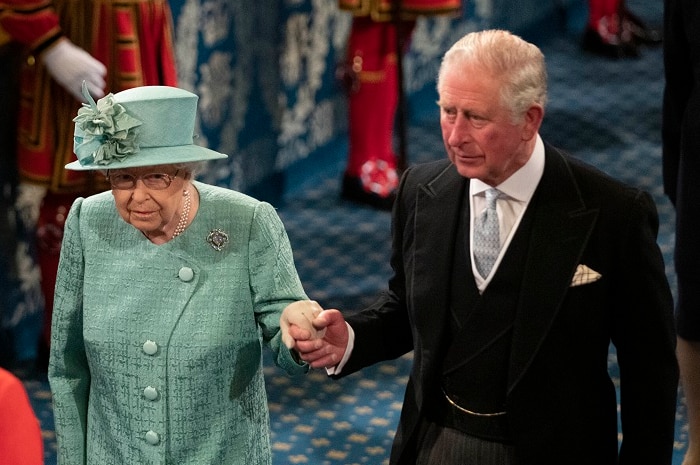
[[0, 0, 177, 352]]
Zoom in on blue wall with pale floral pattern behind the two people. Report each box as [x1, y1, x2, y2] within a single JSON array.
[[171, 0, 580, 201]]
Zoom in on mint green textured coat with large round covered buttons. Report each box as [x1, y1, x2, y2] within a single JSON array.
[[49, 182, 308, 465]]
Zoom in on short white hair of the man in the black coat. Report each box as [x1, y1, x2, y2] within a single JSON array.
[[437, 29, 547, 120]]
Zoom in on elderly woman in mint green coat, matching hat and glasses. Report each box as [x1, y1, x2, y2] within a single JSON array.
[[49, 86, 319, 465]]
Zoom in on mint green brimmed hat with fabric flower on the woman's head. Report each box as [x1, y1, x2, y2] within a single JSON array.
[[66, 83, 227, 171]]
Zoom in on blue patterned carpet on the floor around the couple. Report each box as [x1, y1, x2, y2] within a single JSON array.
[[26, 0, 687, 465]]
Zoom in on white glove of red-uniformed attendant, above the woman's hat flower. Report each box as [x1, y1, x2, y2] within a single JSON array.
[[42, 38, 107, 102]]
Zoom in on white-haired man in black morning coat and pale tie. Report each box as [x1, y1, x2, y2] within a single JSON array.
[[290, 30, 678, 465]]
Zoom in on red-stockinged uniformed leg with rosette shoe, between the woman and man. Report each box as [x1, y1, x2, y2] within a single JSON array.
[[339, 0, 461, 208]]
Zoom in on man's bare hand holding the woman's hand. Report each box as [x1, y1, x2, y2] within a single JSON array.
[[289, 309, 349, 368]]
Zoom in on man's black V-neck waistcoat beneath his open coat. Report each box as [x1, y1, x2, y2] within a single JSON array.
[[441, 192, 535, 413]]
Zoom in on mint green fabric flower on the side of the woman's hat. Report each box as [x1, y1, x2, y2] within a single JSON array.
[[73, 82, 143, 165]]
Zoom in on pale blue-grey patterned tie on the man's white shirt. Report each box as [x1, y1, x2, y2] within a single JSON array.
[[474, 188, 501, 278]]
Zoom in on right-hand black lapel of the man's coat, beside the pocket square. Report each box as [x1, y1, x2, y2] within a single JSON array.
[[508, 146, 598, 392]]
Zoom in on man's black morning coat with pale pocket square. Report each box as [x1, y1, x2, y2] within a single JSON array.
[[340, 145, 678, 465]]
